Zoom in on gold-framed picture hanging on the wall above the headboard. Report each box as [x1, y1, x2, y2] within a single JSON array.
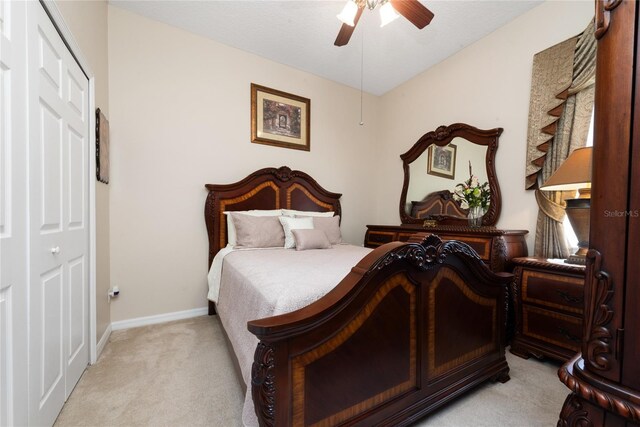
[[251, 83, 311, 151]]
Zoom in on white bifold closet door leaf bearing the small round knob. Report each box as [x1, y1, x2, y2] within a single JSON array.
[[28, 9, 66, 425]]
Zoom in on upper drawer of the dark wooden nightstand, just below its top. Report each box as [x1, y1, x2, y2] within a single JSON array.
[[522, 269, 584, 315]]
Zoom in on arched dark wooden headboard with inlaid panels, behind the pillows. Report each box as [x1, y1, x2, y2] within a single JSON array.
[[204, 166, 342, 265]]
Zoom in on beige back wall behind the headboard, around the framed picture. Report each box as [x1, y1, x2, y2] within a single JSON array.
[[109, 6, 377, 321]]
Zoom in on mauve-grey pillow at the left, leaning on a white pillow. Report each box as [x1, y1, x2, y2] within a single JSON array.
[[230, 212, 284, 248]]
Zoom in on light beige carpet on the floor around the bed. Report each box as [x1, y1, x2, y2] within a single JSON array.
[[55, 316, 569, 427]]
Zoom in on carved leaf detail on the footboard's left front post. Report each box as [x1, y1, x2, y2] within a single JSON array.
[[251, 342, 276, 427]]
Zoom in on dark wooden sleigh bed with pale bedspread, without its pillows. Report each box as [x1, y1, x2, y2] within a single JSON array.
[[205, 167, 512, 426]]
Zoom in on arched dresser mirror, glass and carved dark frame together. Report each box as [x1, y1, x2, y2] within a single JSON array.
[[400, 123, 502, 226]]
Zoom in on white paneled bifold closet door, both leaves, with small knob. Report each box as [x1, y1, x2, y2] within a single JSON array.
[[27, 2, 89, 425]]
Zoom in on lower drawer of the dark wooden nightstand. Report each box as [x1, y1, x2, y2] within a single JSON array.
[[522, 305, 582, 353]]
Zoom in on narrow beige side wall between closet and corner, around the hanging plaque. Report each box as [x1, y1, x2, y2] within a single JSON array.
[[56, 0, 111, 340]]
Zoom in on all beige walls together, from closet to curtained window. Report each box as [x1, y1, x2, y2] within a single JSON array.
[[57, 0, 593, 326]]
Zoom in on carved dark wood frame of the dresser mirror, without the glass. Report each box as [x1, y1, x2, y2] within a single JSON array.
[[400, 123, 503, 226]]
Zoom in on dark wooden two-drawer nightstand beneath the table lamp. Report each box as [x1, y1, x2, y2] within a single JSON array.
[[510, 258, 585, 362]]
